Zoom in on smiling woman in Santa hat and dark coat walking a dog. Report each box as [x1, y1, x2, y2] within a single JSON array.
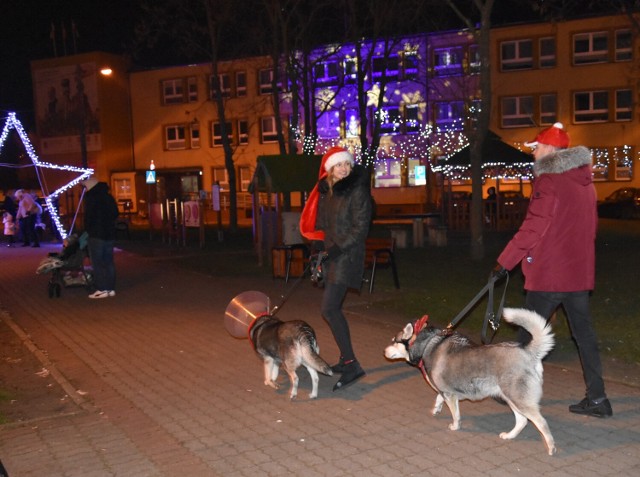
[[301, 147, 372, 391]]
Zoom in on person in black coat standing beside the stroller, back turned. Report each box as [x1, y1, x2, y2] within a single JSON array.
[[80, 179, 120, 299]]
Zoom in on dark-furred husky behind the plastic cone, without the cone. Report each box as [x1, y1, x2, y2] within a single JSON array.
[[249, 314, 333, 399]]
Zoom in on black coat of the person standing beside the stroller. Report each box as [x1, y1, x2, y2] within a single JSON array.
[[84, 182, 120, 240]]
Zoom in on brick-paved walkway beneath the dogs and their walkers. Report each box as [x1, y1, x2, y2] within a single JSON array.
[[0, 240, 640, 477]]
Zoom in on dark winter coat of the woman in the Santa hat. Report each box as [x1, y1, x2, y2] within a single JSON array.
[[316, 165, 371, 290]]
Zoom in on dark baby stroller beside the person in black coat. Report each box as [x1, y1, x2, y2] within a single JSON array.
[[36, 233, 93, 298]]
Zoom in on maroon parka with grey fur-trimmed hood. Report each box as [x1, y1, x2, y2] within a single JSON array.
[[498, 146, 598, 292]]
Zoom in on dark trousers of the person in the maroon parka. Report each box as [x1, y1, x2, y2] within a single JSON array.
[[519, 291, 606, 400]]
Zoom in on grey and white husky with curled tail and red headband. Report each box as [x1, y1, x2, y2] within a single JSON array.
[[384, 308, 556, 455]]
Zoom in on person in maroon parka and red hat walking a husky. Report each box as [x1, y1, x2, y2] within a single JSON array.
[[494, 123, 613, 417]]
